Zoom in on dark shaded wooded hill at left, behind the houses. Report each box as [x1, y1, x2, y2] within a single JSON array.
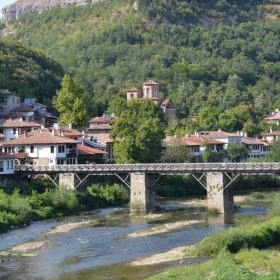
[[0, 40, 64, 111]]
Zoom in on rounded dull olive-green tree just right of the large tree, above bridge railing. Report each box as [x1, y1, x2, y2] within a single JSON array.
[[160, 137, 193, 163]]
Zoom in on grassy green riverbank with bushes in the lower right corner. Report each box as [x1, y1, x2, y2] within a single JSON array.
[[149, 193, 280, 280]]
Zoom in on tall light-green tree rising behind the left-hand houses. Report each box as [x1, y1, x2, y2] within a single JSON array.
[[52, 74, 89, 128]]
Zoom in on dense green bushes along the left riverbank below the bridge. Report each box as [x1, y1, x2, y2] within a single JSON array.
[[0, 180, 129, 233]]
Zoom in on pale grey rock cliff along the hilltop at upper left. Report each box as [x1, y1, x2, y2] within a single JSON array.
[[2, 0, 102, 25]]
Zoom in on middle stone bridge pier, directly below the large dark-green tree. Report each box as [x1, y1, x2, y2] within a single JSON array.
[[130, 172, 156, 213]]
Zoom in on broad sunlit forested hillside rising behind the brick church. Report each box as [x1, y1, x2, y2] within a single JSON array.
[[1, 0, 280, 136]]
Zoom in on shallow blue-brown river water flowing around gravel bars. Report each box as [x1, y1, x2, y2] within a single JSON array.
[[0, 195, 272, 280]]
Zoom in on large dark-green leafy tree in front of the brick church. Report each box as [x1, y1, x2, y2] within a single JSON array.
[[110, 99, 165, 163]]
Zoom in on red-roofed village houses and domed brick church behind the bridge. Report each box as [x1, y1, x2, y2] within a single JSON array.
[[0, 80, 280, 177]]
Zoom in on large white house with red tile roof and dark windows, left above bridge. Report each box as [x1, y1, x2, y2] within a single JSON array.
[[2, 128, 79, 165]]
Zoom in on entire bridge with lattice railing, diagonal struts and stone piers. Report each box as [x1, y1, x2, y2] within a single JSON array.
[[15, 162, 280, 213]]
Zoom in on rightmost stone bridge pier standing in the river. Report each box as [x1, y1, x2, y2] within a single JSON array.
[[206, 172, 234, 213]]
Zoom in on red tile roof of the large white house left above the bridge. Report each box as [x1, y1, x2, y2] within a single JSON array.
[[2, 128, 79, 146]]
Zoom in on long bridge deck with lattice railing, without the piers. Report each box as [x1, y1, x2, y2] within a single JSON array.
[[15, 162, 280, 175]]
